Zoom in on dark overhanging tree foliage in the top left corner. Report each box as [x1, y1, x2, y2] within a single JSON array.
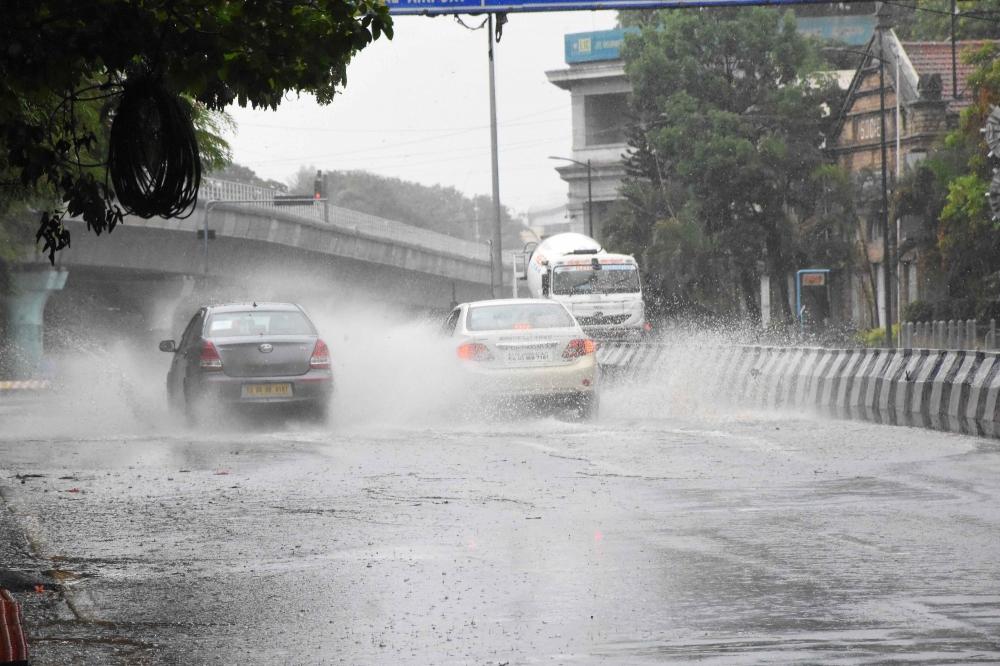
[[0, 0, 392, 268]]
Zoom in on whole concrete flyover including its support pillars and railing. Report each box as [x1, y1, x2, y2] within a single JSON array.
[[0, 179, 490, 379]]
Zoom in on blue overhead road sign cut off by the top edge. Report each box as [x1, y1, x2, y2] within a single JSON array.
[[385, 0, 829, 16]]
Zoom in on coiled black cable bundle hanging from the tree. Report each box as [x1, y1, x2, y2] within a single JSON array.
[[108, 74, 201, 218]]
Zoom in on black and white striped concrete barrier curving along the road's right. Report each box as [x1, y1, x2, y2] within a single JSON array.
[[598, 342, 1000, 437]]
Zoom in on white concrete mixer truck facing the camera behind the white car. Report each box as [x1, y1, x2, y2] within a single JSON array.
[[514, 233, 648, 338]]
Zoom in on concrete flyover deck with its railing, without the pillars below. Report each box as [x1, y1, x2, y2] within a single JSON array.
[[58, 179, 490, 307]]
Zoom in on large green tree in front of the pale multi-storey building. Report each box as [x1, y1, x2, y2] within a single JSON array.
[[609, 8, 846, 317]]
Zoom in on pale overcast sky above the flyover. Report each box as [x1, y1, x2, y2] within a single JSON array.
[[227, 11, 615, 212]]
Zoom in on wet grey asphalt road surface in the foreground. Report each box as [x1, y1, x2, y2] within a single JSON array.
[[0, 384, 1000, 664]]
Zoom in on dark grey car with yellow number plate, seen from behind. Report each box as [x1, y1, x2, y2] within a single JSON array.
[[160, 303, 333, 420]]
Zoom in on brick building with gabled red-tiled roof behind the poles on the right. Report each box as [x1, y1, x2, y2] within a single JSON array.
[[830, 30, 985, 327]]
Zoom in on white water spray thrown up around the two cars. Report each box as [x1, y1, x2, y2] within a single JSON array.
[[0, 272, 800, 439]]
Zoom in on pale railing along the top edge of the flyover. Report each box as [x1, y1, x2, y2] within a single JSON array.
[[199, 178, 490, 262]]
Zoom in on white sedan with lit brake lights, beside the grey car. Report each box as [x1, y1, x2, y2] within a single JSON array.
[[444, 298, 599, 418]]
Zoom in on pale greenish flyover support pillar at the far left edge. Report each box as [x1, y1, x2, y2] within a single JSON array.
[[0, 265, 69, 379]]
